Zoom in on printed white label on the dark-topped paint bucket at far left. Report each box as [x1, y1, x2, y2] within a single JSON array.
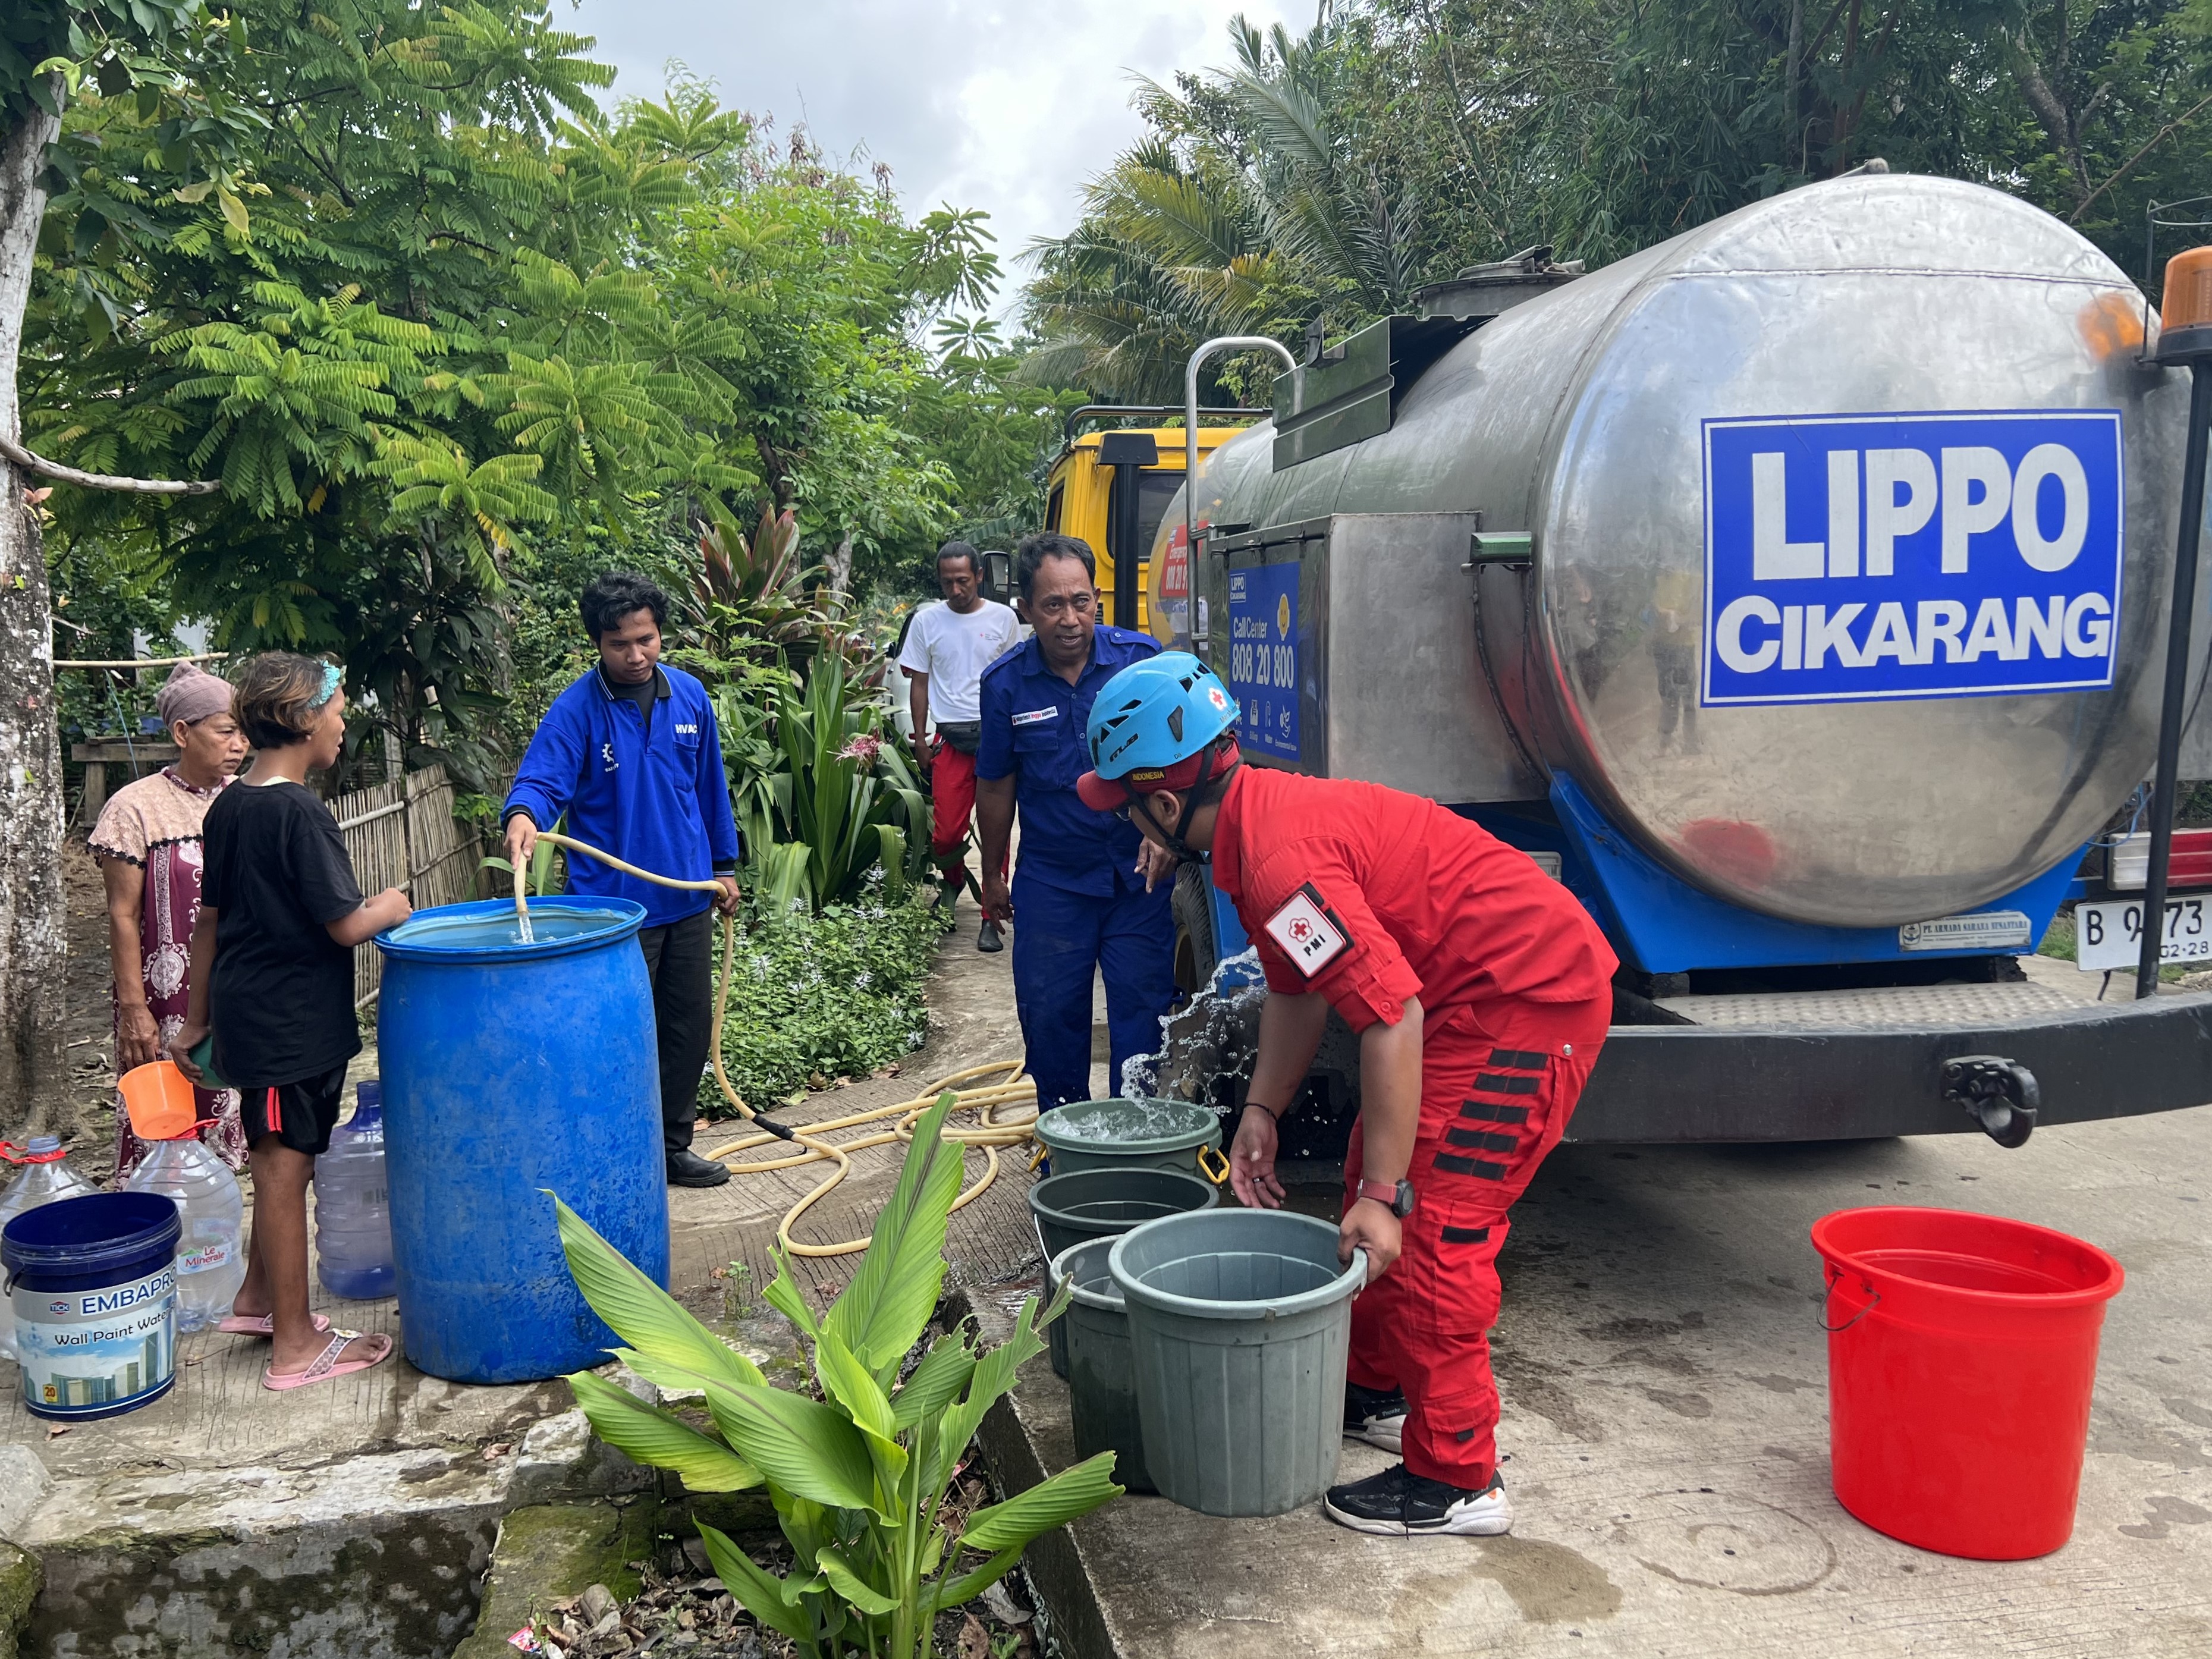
[[13, 1265, 177, 1418]]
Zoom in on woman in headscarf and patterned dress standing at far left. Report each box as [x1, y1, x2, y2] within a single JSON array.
[[93, 664, 246, 1181]]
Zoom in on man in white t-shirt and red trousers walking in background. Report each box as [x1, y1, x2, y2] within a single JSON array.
[[898, 542, 1020, 951]]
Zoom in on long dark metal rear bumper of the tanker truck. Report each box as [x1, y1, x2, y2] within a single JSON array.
[[1566, 993, 2212, 1143]]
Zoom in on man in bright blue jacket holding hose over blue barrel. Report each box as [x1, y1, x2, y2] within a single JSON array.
[[500, 571, 739, 1186]]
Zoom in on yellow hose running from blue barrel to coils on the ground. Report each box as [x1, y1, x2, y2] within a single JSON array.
[[516, 830, 1042, 1256]]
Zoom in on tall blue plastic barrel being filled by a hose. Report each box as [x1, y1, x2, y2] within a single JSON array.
[[376, 898, 668, 1382]]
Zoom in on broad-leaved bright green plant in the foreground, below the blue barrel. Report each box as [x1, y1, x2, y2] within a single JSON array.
[[555, 1091, 1121, 1659]]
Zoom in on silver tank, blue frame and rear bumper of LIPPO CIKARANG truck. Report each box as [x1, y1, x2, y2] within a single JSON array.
[[1148, 172, 2212, 1155]]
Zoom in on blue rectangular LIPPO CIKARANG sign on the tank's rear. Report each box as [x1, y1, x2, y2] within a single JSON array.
[[1699, 409, 2126, 706]]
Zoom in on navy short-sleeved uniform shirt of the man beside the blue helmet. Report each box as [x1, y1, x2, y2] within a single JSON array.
[[976, 621, 1159, 898]]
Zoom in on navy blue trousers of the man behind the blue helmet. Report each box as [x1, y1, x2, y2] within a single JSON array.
[[1013, 865, 1174, 1110]]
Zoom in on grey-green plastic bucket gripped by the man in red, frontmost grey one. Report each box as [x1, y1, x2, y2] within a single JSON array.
[[1108, 1210, 1367, 1515]]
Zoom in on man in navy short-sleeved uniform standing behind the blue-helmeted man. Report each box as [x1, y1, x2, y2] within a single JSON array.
[[976, 533, 1174, 1110]]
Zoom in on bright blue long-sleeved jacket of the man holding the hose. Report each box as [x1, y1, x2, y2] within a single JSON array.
[[500, 668, 739, 927]]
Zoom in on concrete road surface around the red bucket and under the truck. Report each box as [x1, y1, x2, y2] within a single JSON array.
[[991, 964, 2212, 1659]]
